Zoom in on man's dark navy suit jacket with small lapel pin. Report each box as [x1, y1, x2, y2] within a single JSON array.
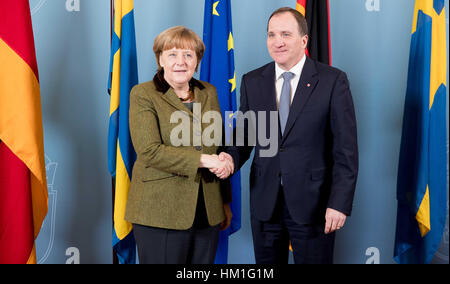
[[227, 58, 358, 224]]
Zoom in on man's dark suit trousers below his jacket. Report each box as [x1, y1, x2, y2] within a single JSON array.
[[251, 187, 335, 264]]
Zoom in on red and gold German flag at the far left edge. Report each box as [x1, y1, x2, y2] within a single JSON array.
[[0, 0, 48, 264]]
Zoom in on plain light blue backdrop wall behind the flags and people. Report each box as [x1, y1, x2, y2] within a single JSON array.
[[30, 0, 448, 264]]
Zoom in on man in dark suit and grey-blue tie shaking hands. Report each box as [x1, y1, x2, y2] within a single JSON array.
[[214, 8, 358, 264]]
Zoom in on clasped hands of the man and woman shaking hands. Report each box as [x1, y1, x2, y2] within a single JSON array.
[[200, 152, 234, 179]]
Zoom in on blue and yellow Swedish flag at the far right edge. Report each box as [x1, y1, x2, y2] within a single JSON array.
[[394, 0, 448, 263]]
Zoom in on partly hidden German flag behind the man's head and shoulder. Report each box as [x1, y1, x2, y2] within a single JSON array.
[[296, 0, 331, 65]]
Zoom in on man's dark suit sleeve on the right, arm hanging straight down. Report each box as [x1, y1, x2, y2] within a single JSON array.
[[328, 72, 358, 215]]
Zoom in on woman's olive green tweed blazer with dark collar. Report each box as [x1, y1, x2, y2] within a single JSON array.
[[125, 74, 231, 230]]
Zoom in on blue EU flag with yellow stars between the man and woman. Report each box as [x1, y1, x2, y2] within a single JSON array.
[[200, 0, 241, 264]]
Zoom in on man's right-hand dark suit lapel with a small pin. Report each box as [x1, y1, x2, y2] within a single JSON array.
[[282, 57, 319, 142]]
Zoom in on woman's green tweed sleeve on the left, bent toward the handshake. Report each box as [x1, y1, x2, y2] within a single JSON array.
[[129, 84, 201, 179]]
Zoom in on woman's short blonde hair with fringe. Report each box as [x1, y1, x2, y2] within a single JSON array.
[[153, 26, 205, 71]]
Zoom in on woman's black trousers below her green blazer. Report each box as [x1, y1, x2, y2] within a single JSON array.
[[133, 187, 220, 264]]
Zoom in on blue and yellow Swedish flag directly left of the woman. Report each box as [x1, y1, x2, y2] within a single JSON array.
[[108, 0, 138, 264]]
